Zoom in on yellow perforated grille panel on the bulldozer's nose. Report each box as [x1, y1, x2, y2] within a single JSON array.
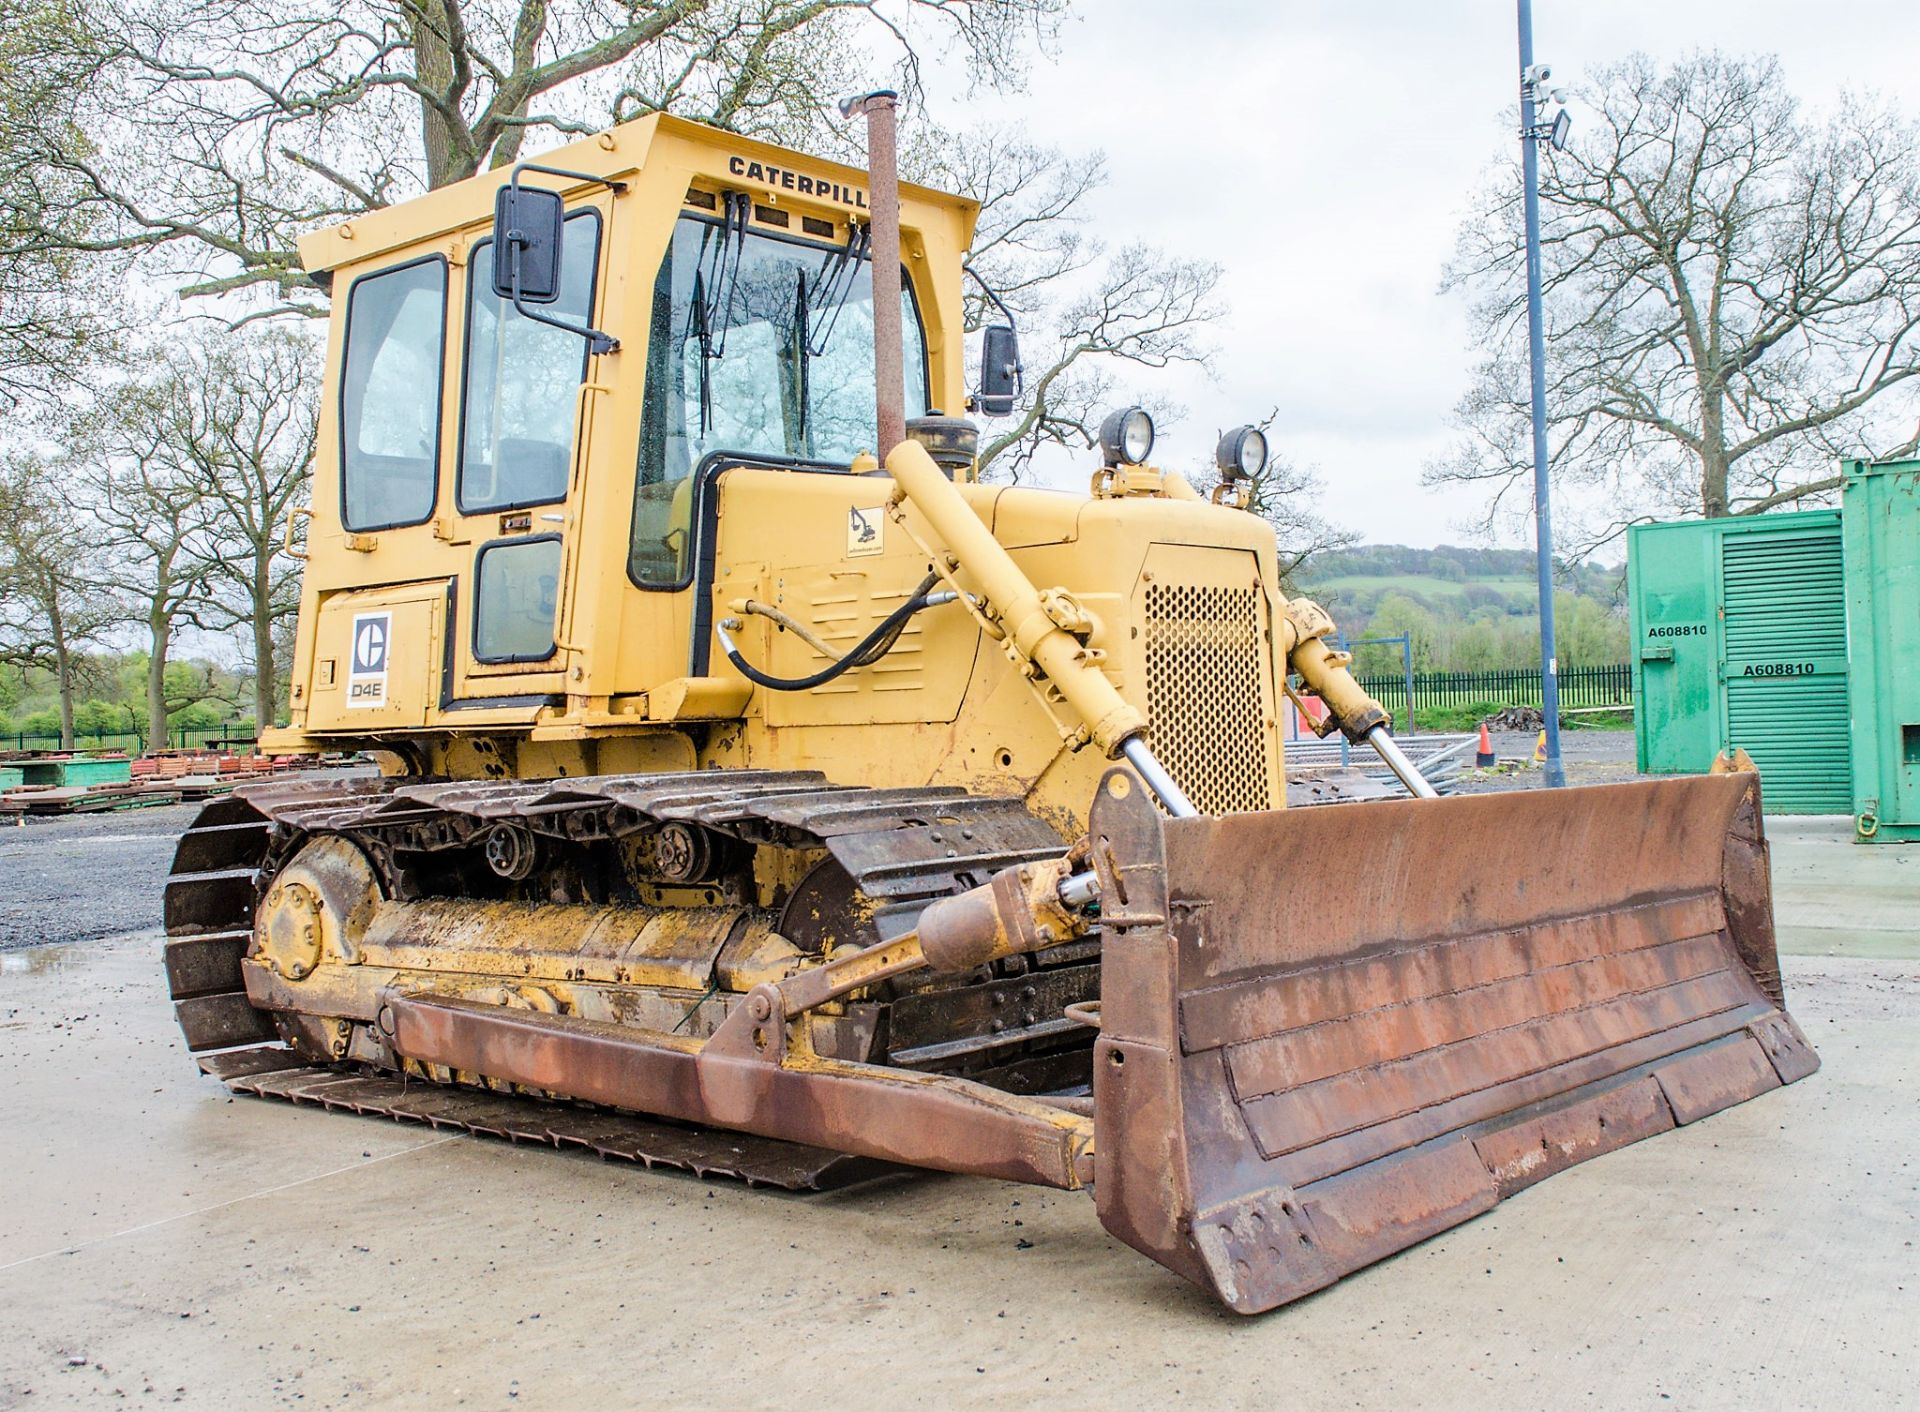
[[1146, 584, 1273, 815]]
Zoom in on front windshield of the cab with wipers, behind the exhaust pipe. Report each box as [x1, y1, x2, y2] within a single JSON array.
[[630, 211, 927, 586]]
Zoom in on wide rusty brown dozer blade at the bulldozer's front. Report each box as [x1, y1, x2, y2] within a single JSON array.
[[1092, 774, 1820, 1314]]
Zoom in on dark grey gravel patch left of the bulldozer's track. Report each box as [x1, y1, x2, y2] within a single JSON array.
[[0, 805, 200, 951]]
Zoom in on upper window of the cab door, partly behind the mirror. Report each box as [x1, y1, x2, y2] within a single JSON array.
[[459, 211, 599, 513]]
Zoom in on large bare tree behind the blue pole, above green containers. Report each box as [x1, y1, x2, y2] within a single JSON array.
[[1427, 54, 1920, 548]]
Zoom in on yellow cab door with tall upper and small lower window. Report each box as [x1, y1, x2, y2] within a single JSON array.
[[440, 198, 609, 711]]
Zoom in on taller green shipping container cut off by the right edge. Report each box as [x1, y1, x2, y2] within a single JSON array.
[[1841, 461, 1920, 843]]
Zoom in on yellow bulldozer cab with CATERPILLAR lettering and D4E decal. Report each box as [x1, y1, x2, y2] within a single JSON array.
[[280, 117, 973, 753]]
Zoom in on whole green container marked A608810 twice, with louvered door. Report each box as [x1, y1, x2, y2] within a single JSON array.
[[1626, 509, 1853, 815]]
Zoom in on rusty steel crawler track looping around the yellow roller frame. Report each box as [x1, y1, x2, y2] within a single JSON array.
[[165, 770, 1062, 1191]]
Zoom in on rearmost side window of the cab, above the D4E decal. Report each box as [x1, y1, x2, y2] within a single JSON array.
[[340, 256, 447, 530]]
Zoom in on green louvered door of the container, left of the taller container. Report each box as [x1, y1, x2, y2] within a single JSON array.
[[1720, 523, 1853, 815]]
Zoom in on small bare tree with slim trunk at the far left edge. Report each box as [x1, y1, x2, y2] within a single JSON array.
[[0, 457, 127, 747]]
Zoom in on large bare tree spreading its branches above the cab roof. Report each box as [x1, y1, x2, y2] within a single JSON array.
[[0, 0, 1064, 311]]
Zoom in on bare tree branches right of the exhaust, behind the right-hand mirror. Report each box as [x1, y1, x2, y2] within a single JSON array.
[[910, 129, 1221, 480]]
